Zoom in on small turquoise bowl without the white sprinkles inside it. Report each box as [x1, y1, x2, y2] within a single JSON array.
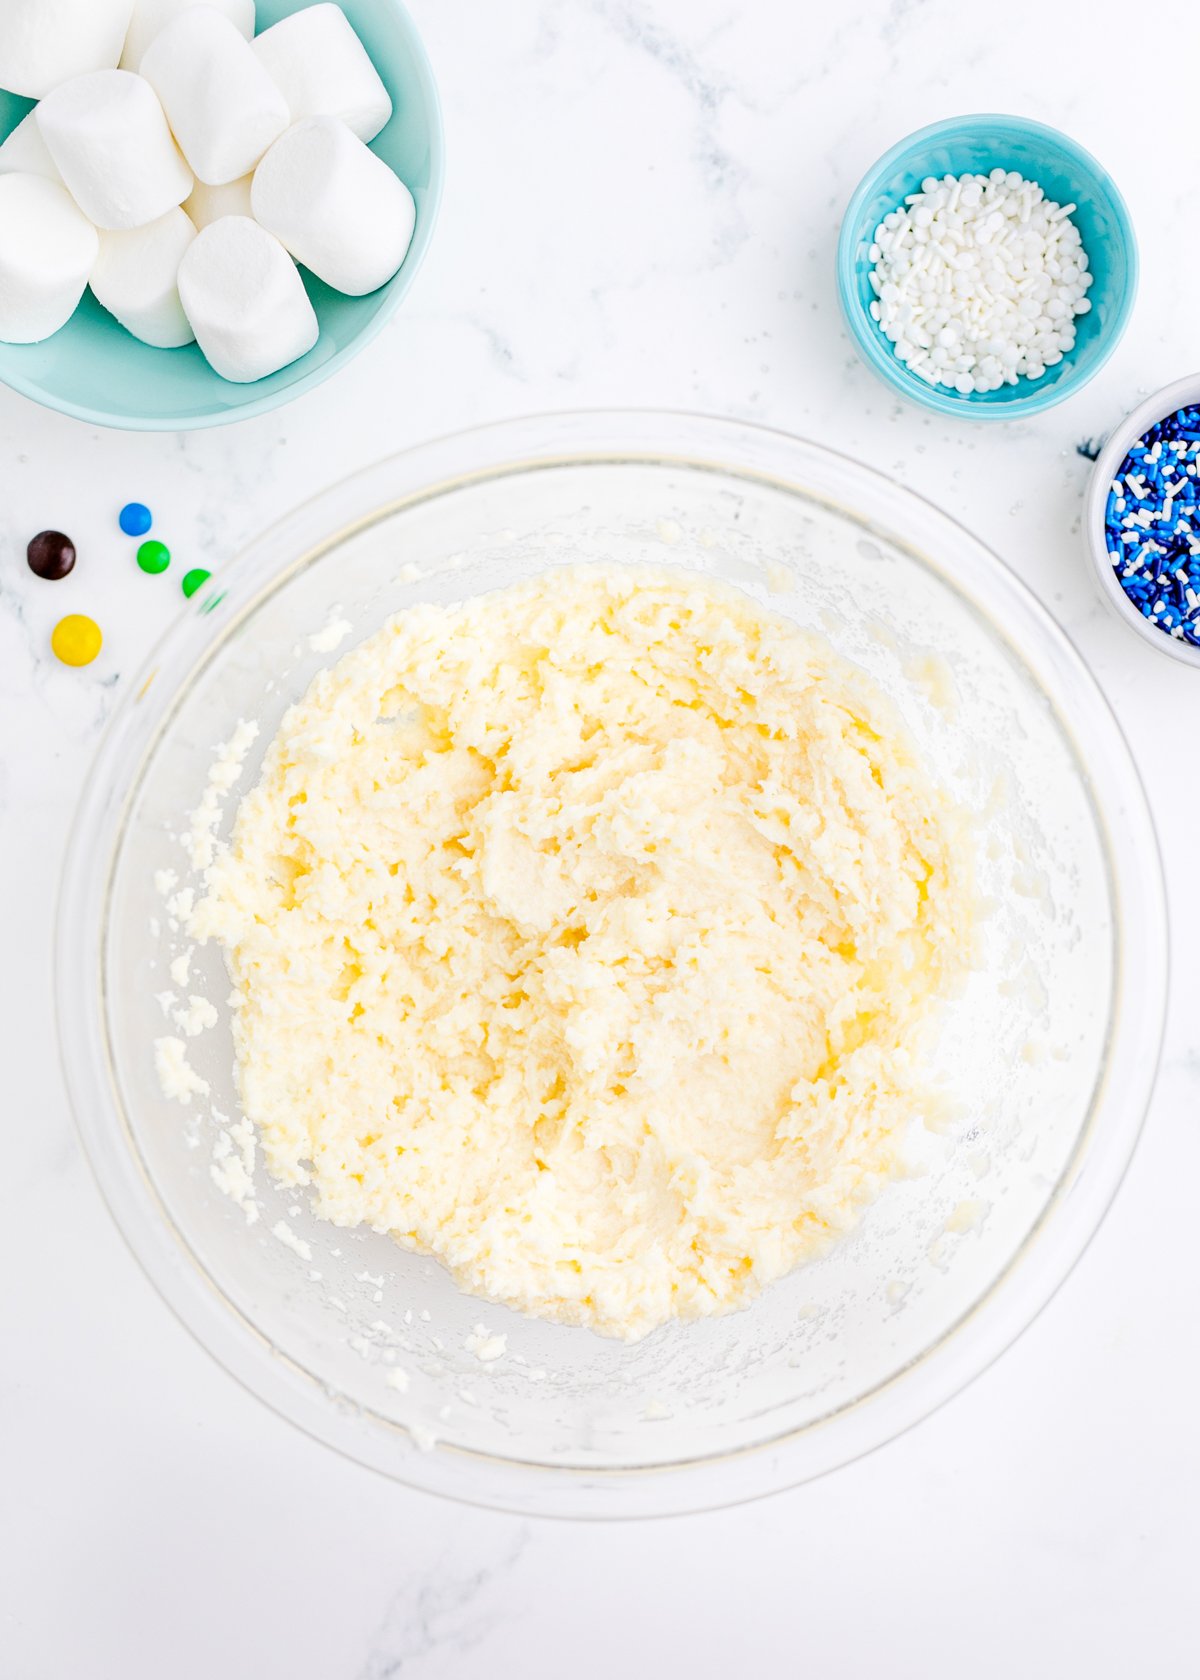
[[837, 116, 1138, 420]]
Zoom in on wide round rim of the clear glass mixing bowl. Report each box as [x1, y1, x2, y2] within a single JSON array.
[[55, 410, 1168, 1519]]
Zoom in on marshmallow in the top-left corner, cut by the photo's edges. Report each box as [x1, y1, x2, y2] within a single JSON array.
[[0, 0, 133, 99]]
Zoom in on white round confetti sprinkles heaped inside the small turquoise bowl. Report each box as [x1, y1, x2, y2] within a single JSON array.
[[867, 168, 1092, 396]]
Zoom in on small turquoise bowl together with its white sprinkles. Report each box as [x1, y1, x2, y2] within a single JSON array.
[[837, 116, 1138, 420]]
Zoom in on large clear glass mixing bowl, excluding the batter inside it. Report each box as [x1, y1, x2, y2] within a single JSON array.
[[57, 413, 1166, 1517]]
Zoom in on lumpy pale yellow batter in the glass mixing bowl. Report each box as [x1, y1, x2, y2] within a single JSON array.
[[192, 568, 970, 1337]]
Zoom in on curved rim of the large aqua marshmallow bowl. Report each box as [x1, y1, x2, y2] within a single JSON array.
[[0, 0, 445, 433]]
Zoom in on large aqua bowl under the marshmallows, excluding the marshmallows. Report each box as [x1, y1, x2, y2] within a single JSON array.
[[0, 0, 444, 432]]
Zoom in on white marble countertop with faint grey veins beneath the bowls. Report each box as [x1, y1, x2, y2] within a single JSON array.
[[0, 0, 1200, 1680]]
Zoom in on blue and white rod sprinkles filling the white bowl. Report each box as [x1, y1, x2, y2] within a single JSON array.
[[1104, 403, 1200, 647]]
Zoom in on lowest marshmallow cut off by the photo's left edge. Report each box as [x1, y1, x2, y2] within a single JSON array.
[[0, 175, 98, 344]]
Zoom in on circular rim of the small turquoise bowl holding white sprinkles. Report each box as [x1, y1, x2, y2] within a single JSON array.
[[837, 111, 1139, 420]]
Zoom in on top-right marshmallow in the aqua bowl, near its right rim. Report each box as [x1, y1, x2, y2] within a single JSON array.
[[254, 5, 392, 139]]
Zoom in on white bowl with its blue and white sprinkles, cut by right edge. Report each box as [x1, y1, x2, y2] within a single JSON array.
[[1084, 373, 1200, 669]]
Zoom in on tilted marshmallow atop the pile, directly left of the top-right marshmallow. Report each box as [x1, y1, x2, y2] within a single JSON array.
[[141, 5, 289, 186]]
